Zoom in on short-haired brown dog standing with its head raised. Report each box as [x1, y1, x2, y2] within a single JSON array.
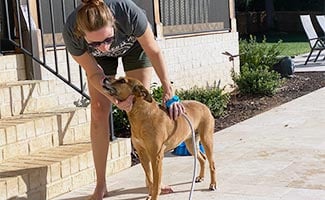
[[103, 78, 217, 200]]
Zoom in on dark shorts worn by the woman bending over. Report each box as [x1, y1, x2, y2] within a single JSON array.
[[95, 45, 152, 76]]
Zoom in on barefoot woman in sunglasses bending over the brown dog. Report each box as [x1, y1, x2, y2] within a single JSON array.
[[63, 0, 184, 200]]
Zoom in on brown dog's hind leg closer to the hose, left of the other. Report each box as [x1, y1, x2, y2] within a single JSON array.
[[185, 138, 206, 183]]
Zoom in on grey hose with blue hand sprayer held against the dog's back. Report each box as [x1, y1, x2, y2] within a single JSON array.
[[166, 96, 198, 200]]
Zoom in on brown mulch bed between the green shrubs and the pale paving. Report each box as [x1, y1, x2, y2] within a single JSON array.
[[215, 72, 325, 132]]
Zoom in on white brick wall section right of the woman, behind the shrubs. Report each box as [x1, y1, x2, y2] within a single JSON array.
[[154, 32, 239, 89]]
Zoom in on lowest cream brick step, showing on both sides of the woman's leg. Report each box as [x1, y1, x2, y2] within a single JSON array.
[[0, 138, 131, 200]]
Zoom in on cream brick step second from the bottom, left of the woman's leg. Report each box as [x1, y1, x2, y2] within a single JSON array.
[[0, 107, 90, 163]]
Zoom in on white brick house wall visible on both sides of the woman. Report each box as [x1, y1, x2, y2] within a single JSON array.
[[41, 32, 239, 104]]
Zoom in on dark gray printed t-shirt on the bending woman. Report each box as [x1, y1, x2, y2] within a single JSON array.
[[63, 0, 148, 57]]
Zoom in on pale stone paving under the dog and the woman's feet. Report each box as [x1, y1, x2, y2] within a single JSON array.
[[56, 58, 325, 200]]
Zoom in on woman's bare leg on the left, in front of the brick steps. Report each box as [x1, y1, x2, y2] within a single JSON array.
[[89, 80, 111, 200]]
